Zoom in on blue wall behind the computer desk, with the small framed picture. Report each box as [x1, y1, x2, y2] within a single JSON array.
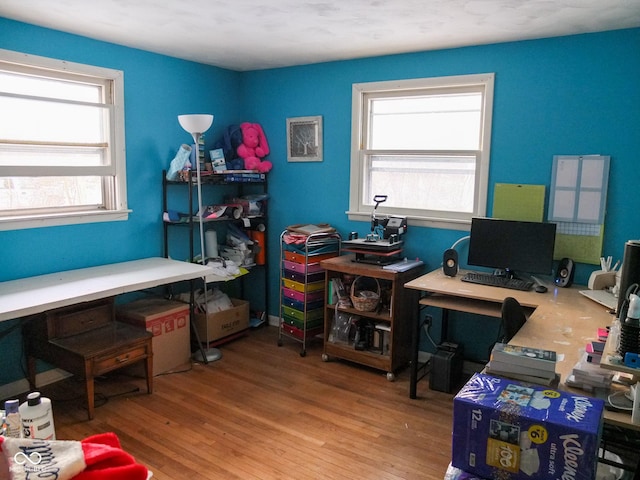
[[242, 29, 640, 358]]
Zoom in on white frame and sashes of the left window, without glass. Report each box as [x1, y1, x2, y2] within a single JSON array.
[[0, 49, 130, 231]]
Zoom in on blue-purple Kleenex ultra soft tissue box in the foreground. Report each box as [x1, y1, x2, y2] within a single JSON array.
[[451, 373, 604, 480]]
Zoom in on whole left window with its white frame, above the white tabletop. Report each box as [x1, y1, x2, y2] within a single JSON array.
[[0, 50, 128, 230]]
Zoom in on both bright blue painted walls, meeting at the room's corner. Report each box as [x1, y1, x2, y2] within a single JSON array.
[[0, 18, 640, 384]]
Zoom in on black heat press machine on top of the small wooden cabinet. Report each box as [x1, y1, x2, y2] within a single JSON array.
[[342, 195, 407, 265]]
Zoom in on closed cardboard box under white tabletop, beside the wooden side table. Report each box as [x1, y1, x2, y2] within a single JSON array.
[[116, 298, 191, 375]]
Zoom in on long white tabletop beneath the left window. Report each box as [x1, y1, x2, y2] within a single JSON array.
[[0, 257, 211, 321]]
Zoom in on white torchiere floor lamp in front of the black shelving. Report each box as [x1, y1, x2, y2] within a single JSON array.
[[178, 114, 222, 363]]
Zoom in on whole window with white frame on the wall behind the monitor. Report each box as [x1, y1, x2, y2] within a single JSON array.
[[348, 74, 494, 229]]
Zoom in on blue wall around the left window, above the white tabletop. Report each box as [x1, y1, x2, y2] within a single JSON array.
[[0, 18, 241, 384]]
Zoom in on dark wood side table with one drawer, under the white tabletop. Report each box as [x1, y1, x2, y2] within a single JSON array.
[[23, 297, 153, 420]]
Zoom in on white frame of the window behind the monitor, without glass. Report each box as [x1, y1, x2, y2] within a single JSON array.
[[346, 73, 495, 230]]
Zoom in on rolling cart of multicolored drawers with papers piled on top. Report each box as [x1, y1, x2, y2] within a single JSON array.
[[278, 230, 341, 357]]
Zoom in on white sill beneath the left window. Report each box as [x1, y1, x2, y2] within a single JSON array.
[[0, 210, 131, 231]]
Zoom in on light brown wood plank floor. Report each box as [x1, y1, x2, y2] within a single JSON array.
[[43, 327, 453, 480]]
